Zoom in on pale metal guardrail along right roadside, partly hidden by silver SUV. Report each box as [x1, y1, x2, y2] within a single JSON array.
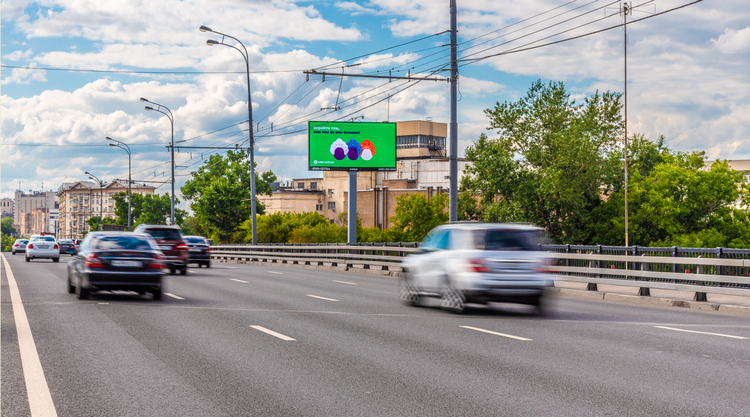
[[212, 242, 750, 301]]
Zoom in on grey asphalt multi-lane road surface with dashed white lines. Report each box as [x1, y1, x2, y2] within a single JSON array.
[[0, 254, 750, 417]]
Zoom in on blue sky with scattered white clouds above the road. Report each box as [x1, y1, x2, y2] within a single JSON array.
[[0, 0, 750, 208]]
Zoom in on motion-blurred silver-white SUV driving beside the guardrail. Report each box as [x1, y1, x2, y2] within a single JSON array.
[[400, 223, 549, 313]]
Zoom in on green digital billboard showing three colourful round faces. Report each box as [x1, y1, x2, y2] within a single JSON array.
[[308, 122, 396, 171]]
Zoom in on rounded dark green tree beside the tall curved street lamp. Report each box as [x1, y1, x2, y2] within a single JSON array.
[[181, 149, 276, 242]]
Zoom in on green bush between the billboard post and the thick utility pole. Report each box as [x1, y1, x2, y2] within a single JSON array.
[[386, 194, 448, 242]]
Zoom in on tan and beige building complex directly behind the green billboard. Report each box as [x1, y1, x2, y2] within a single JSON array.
[[258, 120, 467, 229]]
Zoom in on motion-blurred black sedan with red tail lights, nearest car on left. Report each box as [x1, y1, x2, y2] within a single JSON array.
[[67, 232, 165, 300]]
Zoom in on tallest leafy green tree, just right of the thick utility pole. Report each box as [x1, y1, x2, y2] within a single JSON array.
[[463, 81, 622, 243]]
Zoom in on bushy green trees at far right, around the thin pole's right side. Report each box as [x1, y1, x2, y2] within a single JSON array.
[[590, 152, 750, 247]]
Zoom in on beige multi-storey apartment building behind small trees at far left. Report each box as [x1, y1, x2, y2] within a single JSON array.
[[57, 181, 155, 239]]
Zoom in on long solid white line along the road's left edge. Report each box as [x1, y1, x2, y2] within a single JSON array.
[[0, 254, 57, 417]]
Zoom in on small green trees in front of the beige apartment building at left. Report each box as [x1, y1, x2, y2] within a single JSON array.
[[113, 192, 186, 230]]
